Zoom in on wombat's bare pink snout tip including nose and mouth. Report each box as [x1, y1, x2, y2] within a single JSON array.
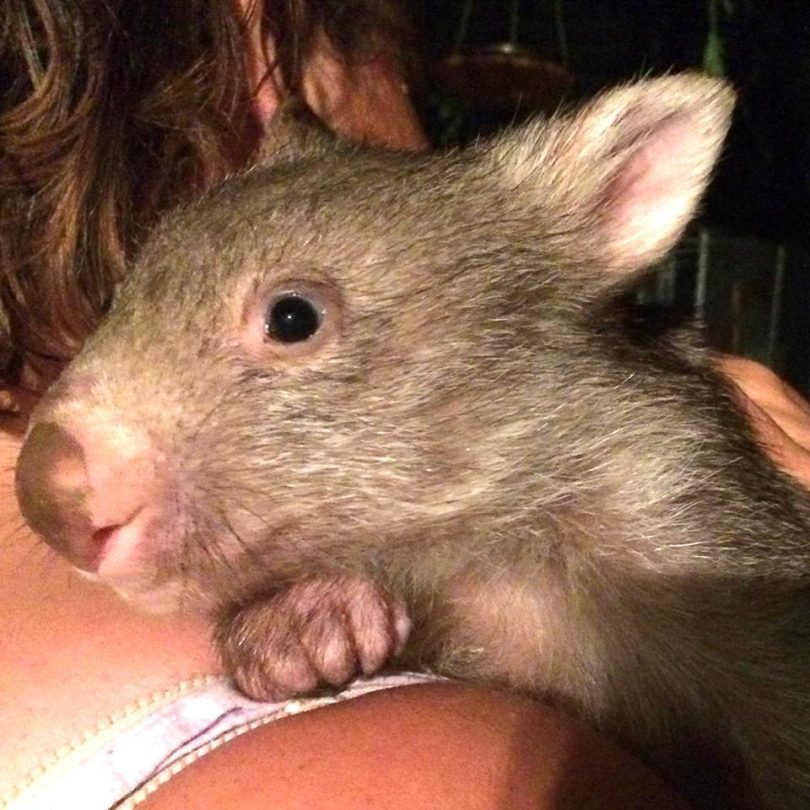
[[16, 388, 168, 574]]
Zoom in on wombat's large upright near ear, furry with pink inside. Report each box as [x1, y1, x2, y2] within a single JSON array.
[[490, 74, 734, 280]]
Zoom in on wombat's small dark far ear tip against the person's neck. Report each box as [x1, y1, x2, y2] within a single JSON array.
[[253, 97, 336, 166]]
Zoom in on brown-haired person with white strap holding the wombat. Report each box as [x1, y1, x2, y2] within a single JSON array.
[[0, 0, 810, 810]]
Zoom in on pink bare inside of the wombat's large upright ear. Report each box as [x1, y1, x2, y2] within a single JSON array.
[[605, 114, 715, 271]]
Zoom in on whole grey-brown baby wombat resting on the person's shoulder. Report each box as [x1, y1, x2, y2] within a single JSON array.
[[17, 76, 810, 810]]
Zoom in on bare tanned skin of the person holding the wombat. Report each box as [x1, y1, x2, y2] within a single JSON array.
[[0, 4, 810, 810]]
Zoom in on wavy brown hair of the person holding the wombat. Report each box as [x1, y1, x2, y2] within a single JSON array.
[[0, 0, 408, 382]]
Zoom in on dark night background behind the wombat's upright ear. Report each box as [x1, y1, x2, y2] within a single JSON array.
[[411, 0, 810, 394]]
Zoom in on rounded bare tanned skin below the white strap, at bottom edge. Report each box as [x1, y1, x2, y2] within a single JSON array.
[[141, 684, 686, 810]]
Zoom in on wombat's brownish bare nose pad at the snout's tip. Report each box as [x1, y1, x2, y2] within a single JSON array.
[[16, 422, 98, 571]]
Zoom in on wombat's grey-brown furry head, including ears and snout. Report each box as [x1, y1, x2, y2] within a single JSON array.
[[17, 76, 732, 607]]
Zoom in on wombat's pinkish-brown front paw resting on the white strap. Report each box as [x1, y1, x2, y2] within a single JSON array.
[[217, 576, 410, 700]]
